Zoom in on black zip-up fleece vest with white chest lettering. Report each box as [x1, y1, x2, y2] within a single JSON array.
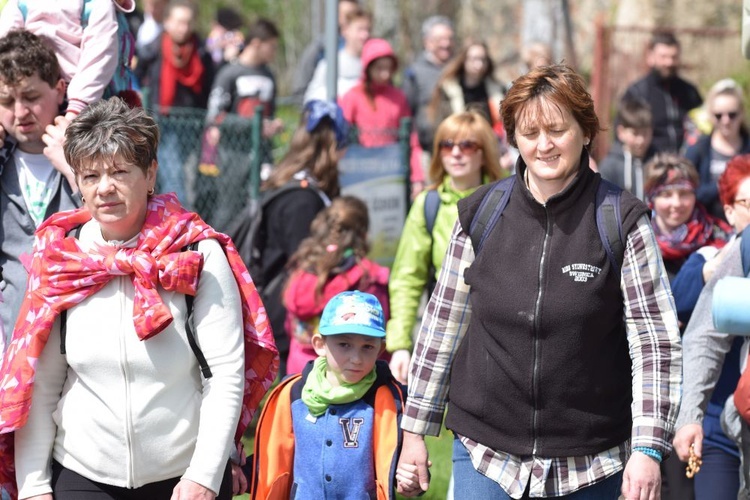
[[446, 161, 648, 457]]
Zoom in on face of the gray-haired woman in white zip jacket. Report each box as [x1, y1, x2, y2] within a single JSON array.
[[76, 157, 157, 240]]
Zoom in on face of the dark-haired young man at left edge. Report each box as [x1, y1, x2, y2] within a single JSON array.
[[0, 75, 65, 154]]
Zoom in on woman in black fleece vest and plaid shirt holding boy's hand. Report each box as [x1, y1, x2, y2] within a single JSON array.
[[398, 65, 682, 500]]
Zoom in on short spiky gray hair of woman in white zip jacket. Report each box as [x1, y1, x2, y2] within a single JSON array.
[[63, 97, 159, 175]]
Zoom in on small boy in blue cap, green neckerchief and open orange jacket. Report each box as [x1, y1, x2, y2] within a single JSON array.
[[250, 291, 418, 499]]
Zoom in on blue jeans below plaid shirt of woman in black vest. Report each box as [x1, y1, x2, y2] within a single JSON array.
[[453, 438, 622, 500]]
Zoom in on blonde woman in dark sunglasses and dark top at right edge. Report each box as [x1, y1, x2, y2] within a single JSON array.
[[685, 78, 750, 218]]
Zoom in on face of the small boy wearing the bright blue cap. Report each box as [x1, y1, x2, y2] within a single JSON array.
[[313, 333, 385, 387]]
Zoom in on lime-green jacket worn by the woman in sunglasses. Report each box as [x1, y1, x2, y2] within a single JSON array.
[[385, 176, 484, 352]]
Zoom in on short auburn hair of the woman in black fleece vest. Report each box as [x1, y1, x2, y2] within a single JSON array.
[[500, 64, 601, 147]]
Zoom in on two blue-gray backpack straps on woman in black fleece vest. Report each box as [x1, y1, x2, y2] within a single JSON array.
[[469, 175, 625, 273]]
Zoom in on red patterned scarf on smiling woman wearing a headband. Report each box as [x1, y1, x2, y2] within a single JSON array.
[[652, 204, 732, 260]]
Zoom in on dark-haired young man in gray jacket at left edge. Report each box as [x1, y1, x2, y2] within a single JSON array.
[[0, 30, 80, 354]]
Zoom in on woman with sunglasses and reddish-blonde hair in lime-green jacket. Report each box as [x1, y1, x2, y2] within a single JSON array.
[[386, 111, 503, 384]]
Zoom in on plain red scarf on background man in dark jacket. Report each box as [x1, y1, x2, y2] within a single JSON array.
[[159, 34, 205, 109]]
